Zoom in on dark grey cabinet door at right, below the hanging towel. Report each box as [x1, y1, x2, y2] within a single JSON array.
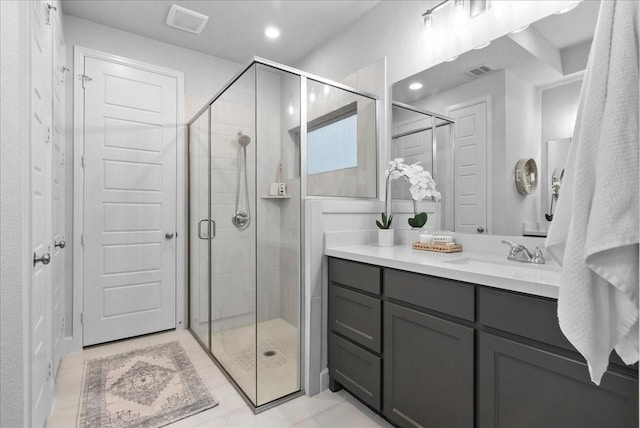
[[478, 333, 638, 428]]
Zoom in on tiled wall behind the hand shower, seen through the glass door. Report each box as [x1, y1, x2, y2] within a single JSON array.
[[211, 88, 256, 333]]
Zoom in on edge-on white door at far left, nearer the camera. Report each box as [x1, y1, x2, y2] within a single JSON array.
[[30, 1, 53, 427]]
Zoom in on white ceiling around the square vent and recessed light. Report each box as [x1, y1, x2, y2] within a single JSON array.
[[62, 0, 379, 65]]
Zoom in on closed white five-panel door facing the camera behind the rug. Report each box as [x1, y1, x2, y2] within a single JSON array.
[[83, 57, 177, 346]]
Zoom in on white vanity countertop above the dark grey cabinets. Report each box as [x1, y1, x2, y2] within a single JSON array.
[[325, 244, 560, 299]]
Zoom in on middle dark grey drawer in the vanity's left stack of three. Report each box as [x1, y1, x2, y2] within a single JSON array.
[[329, 285, 382, 353]]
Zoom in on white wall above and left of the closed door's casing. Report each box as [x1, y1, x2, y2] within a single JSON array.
[[64, 15, 241, 341]]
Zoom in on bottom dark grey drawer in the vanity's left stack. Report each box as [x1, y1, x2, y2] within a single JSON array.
[[329, 333, 382, 411]]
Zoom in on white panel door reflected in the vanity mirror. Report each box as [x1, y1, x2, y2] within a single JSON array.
[[449, 101, 487, 233]]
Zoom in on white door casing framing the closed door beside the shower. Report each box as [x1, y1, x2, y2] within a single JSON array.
[[67, 45, 188, 352]]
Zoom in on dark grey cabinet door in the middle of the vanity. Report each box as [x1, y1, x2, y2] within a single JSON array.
[[383, 303, 474, 427]]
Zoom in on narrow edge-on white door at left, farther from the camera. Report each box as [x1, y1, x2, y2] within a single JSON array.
[[51, 7, 67, 377]]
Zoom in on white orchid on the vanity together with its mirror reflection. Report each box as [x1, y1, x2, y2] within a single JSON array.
[[376, 158, 441, 229]]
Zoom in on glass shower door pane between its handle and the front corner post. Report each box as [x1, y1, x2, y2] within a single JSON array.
[[210, 67, 256, 405]]
